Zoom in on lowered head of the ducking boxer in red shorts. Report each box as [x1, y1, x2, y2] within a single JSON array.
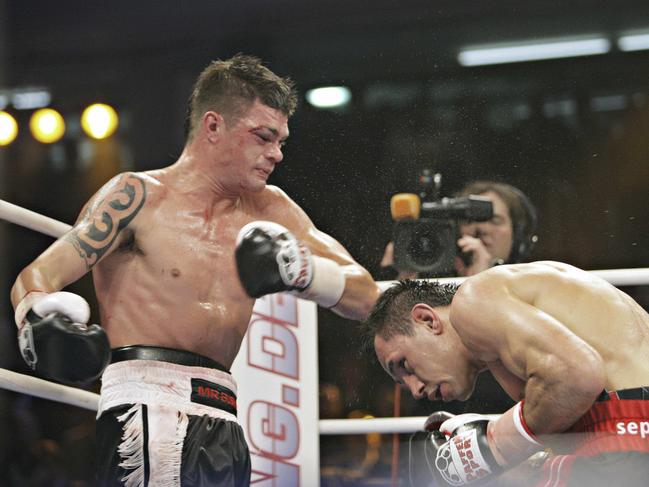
[[363, 279, 479, 401]]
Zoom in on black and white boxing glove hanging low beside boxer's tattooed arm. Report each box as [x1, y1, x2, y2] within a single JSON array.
[[16, 291, 110, 385]]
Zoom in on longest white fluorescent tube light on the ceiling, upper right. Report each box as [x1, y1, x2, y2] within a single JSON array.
[[458, 37, 611, 66]]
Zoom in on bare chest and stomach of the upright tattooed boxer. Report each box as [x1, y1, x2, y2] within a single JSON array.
[[94, 179, 270, 358]]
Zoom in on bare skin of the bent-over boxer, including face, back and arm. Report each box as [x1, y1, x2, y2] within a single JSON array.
[[375, 262, 649, 435]]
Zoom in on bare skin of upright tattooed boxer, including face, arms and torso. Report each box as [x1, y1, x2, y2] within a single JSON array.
[[12, 101, 379, 368]]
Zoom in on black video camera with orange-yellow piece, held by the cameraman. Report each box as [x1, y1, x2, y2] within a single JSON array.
[[390, 169, 493, 277]]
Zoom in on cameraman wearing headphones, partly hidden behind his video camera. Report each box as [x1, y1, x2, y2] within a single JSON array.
[[381, 181, 537, 279]]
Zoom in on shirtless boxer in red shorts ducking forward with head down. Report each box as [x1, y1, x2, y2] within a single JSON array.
[[365, 262, 649, 486]]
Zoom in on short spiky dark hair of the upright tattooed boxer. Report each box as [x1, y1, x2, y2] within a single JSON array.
[[185, 54, 297, 138]]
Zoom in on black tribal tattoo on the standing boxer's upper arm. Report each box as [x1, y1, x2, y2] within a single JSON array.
[[64, 174, 146, 270]]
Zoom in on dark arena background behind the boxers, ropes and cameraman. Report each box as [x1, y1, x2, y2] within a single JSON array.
[[0, 0, 649, 485]]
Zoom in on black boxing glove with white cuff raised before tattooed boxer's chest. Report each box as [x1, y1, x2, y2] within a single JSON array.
[[235, 221, 345, 308]]
